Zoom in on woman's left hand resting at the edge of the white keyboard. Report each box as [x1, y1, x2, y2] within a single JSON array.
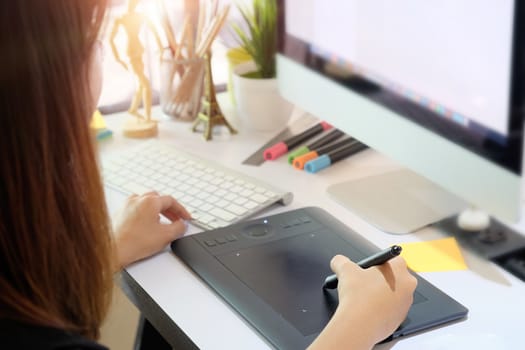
[[115, 192, 191, 269]]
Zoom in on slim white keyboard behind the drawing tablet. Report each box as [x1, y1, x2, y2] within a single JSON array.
[[102, 141, 293, 229]]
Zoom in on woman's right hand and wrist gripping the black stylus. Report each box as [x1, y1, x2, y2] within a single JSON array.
[[311, 255, 417, 349]]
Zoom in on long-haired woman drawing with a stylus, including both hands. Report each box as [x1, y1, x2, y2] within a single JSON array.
[[0, 0, 416, 349]]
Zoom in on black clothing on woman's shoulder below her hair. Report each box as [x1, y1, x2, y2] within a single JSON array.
[[0, 320, 107, 350]]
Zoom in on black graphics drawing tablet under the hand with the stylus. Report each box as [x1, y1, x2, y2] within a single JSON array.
[[171, 208, 467, 349]]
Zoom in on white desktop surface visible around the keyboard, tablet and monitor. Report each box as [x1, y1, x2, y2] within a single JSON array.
[[100, 100, 525, 350]]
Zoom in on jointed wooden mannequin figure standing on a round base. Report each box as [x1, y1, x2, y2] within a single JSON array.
[[110, 0, 162, 138]]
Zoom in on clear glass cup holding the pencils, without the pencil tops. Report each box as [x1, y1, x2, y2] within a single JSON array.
[[160, 57, 206, 121]]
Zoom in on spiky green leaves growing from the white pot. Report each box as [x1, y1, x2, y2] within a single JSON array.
[[232, 0, 277, 78]]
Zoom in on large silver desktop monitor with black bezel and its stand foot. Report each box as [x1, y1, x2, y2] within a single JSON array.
[[277, 0, 525, 233]]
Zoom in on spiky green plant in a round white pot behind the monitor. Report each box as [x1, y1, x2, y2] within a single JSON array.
[[232, 0, 292, 131]]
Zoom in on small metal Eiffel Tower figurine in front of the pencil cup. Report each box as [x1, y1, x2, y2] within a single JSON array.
[[191, 51, 237, 141]]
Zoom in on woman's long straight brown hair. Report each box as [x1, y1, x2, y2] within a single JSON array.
[[0, 0, 112, 339]]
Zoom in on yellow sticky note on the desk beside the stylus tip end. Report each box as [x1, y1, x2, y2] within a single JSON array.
[[400, 237, 467, 272]]
